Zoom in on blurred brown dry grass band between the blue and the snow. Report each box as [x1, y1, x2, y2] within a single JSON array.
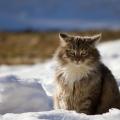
[[0, 30, 120, 65]]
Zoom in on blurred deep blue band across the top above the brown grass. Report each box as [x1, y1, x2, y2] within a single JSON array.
[[0, 0, 120, 31]]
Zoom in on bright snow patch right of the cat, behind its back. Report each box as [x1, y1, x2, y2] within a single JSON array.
[[98, 40, 120, 85]]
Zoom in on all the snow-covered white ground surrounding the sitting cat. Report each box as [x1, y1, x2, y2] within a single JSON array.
[[0, 40, 120, 120]]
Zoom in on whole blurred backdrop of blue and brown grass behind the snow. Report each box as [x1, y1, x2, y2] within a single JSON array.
[[0, 0, 120, 65]]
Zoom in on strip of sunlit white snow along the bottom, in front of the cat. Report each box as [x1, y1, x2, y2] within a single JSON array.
[[0, 109, 120, 120]]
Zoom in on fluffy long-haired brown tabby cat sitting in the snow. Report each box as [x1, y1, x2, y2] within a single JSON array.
[[54, 33, 120, 115]]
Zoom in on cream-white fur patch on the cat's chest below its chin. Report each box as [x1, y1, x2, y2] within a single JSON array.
[[61, 63, 93, 86]]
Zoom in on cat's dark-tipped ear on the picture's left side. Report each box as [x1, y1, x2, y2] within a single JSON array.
[[59, 33, 72, 45]]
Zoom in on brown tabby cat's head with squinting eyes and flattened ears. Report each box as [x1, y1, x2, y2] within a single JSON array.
[[56, 33, 101, 66]]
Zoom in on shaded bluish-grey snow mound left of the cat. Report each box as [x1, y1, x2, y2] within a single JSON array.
[[0, 76, 52, 114]]
